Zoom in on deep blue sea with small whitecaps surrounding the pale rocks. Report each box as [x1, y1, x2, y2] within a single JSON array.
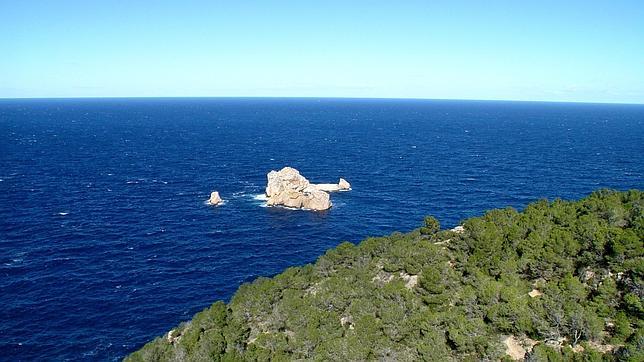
[[0, 99, 644, 361]]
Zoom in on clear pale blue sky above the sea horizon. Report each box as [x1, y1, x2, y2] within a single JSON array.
[[0, 0, 644, 103]]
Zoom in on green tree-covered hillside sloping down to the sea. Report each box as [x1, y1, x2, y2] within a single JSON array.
[[126, 190, 644, 361]]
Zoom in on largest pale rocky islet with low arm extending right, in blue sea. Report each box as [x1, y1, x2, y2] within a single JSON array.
[[266, 167, 351, 211]]
